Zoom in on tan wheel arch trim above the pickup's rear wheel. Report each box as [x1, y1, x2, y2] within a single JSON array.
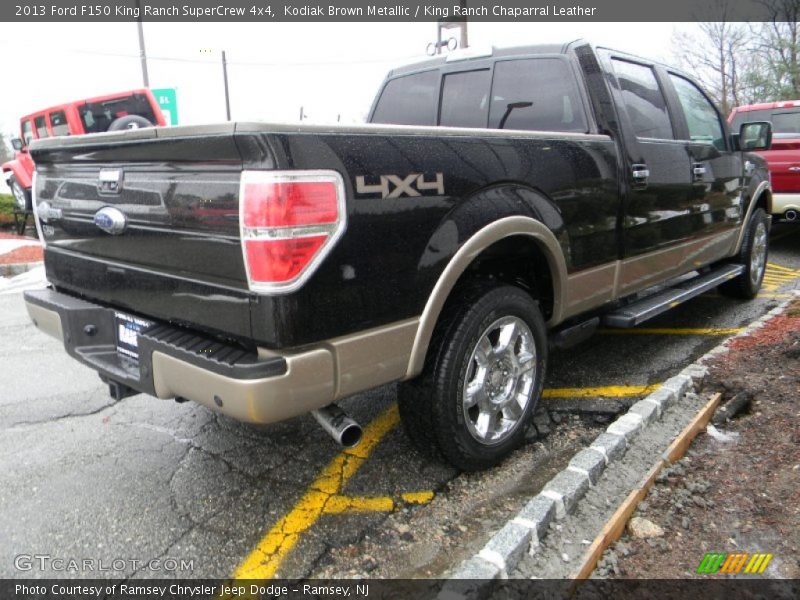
[[404, 215, 567, 379]]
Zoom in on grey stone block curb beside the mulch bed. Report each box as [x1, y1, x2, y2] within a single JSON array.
[[439, 291, 800, 600]]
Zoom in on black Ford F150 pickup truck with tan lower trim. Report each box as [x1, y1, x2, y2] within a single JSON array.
[[26, 41, 771, 469]]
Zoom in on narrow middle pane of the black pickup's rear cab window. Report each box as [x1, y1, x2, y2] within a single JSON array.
[[439, 69, 491, 127]]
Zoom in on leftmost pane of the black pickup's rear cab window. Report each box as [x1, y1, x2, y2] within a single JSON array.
[[371, 70, 439, 126]]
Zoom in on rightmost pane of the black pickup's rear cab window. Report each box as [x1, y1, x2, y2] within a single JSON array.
[[489, 58, 587, 133]]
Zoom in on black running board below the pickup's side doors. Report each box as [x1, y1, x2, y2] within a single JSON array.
[[603, 264, 744, 327]]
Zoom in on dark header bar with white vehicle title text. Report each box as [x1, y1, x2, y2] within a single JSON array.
[[0, 0, 796, 23]]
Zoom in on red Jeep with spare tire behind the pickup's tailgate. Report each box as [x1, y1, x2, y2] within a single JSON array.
[[3, 90, 166, 217]]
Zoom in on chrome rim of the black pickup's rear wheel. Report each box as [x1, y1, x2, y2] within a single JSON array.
[[462, 316, 536, 445]]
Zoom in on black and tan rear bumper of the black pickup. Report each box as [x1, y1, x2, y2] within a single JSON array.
[[25, 289, 336, 423]]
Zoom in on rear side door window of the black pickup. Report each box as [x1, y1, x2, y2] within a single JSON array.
[[612, 58, 675, 140]]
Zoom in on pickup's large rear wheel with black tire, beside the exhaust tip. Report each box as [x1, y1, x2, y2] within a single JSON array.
[[399, 283, 547, 471]]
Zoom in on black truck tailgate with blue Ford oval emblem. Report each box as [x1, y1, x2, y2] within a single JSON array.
[[33, 130, 251, 338]]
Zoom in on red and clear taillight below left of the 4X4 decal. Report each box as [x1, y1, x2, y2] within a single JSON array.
[[239, 171, 347, 293]]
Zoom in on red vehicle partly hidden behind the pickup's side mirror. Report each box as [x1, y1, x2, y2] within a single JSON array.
[[728, 100, 800, 221]]
